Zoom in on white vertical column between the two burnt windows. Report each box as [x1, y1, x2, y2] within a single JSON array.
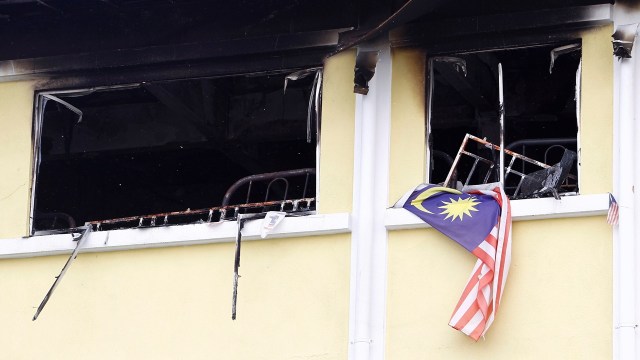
[[349, 46, 391, 360]]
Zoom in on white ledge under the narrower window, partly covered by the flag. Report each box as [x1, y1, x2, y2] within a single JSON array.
[[385, 194, 609, 230]]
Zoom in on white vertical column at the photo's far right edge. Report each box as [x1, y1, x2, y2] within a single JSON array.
[[613, 27, 640, 360]]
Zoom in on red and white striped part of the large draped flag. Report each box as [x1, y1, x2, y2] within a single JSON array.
[[449, 187, 511, 341]]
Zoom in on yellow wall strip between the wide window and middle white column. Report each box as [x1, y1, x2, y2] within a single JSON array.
[[318, 50, 356, 213]]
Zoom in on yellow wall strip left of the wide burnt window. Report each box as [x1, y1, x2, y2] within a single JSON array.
[[0, 81, 34, 239]]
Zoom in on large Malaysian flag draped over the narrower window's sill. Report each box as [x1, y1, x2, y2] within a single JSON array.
[[396, 184, 511, 341]]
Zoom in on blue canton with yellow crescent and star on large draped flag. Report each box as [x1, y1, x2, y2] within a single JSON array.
[[403, 185, 500, 252]]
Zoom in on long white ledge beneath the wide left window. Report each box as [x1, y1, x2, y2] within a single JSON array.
[[0, 213, 351, 259]]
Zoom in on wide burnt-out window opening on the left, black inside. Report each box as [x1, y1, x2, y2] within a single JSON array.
[[32, 73, 319, 232]]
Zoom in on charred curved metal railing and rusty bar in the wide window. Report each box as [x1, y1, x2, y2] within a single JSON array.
[[85, 168, 316, 231]]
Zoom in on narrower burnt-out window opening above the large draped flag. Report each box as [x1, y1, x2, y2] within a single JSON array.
[[427, 45, 581, 198]]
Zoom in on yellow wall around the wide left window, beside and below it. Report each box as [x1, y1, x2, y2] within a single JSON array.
[[0, 52, 355, 360]]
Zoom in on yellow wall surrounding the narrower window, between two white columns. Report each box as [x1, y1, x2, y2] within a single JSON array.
[[386, 26, 613, 360]]
